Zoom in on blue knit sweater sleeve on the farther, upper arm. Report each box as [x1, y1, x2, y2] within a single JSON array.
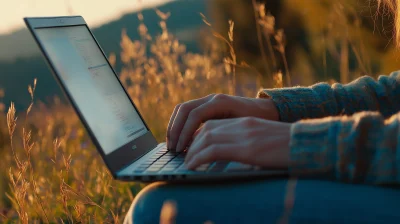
[[258, 72, 400, 122]]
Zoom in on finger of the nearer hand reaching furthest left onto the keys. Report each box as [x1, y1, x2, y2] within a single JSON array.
[[185, 129, 235, 163]]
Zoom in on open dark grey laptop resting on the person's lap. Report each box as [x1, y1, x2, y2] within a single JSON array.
[[24, 16, 287, 182]]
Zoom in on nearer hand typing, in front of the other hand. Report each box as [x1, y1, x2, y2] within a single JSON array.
[[185, 117, 291, 169]]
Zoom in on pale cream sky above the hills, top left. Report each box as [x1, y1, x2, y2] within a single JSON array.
[[0, 0, 171, 35]]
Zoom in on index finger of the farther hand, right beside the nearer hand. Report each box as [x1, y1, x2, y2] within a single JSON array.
[[176, 100, 223, 152]]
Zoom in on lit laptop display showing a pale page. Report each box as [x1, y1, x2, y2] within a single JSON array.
[[36, 25, 148, 155]]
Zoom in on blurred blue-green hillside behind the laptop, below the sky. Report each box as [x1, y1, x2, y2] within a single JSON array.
[[0, 0, 207, 109]]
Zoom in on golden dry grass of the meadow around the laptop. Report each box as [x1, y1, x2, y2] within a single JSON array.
[[0, 1, 384, 223]]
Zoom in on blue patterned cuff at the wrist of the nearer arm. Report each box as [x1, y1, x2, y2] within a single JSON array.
[[289, 117, 340, 179]]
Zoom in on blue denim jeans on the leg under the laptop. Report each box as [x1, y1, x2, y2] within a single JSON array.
[[125, 179, 400, 224]]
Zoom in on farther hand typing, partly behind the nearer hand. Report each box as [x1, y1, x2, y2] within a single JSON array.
[[167, 94, 279, 152]]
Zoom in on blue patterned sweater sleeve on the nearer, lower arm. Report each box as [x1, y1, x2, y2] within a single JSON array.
[[289, 112, 400, 184]]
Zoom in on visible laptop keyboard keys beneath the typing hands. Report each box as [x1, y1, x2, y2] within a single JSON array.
[[134, 147, 229, 173]]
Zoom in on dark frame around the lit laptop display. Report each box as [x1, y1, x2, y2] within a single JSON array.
[[24, 16, 158, 177]]
